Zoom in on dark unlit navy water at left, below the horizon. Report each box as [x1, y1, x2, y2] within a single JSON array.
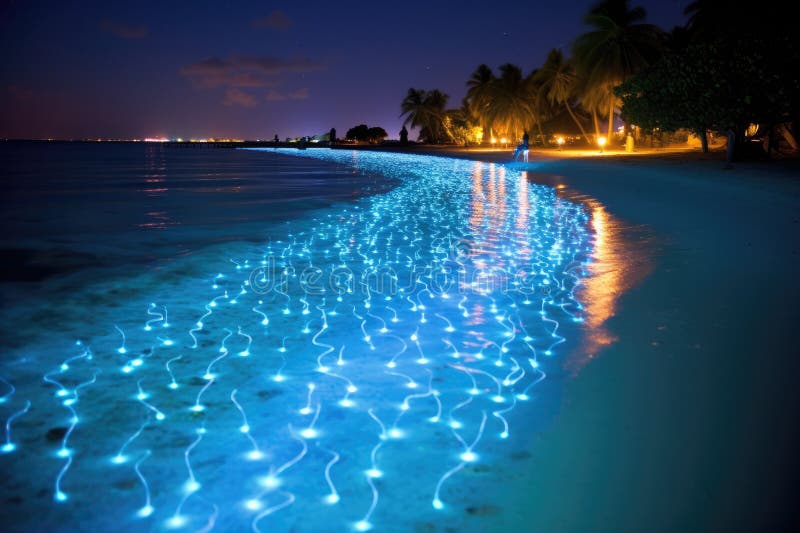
[[0, 142, 392, 281]]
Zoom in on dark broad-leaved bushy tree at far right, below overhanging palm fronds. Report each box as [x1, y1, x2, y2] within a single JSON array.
[[616, 20, 800, 152]]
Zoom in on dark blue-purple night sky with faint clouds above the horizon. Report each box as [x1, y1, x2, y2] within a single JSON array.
[[0, 0, 688, 139]]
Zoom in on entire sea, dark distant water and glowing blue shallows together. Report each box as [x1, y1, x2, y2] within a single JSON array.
[[0, 144, 620, 531]]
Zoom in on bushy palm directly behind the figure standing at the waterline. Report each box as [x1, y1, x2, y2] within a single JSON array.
[[487, 63, 533, 139]]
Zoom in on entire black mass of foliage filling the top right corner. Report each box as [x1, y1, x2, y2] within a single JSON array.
[[616, 0, 800, 154]]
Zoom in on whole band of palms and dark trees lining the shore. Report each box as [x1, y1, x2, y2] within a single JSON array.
[[401, 0, 800, 158]]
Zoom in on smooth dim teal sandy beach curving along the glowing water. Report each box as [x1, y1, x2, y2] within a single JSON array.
[[424, 145, 800, 531]]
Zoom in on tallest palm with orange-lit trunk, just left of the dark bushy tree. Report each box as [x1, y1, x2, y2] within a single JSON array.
[[573, 0, 662, 140]]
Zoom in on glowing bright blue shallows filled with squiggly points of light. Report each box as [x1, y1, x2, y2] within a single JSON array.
[[0, 149, 592, 531]]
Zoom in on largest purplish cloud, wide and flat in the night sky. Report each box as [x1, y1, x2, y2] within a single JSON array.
[[180, 56, 326, 89]]
